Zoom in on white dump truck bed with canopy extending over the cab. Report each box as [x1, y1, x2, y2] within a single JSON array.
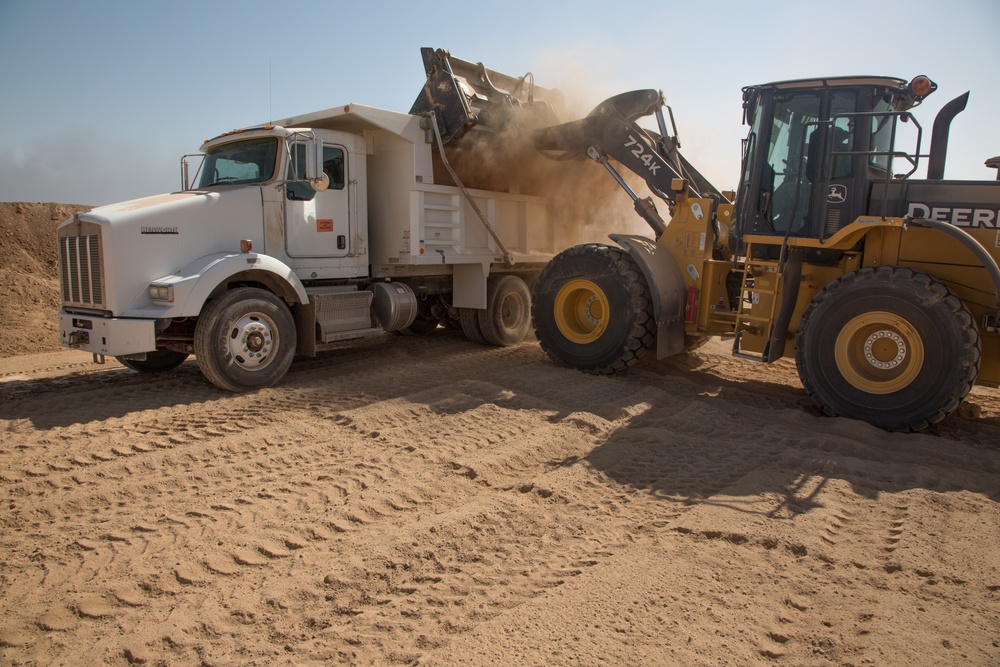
[[276, 104, 560, 277]]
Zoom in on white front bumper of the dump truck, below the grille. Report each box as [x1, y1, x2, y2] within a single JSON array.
[[59, 312, 156, 357]]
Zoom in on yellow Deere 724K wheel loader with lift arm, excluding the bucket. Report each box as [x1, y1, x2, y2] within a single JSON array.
[[532, 76, 1000, 431]]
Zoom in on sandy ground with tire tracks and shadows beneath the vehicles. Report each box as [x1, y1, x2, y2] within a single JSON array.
[[0, 330, 1000, 665]]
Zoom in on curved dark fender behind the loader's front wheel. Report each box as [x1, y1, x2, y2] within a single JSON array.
[[610, 234, 687, 359]]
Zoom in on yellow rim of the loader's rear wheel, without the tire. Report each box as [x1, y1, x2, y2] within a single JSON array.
[[834, 311, 924, 394]]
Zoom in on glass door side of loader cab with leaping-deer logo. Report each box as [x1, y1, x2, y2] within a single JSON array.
[[739, 89, 866, 243]]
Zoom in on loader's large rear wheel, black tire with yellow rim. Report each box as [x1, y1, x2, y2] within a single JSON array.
[[795, 266, 980, 431]]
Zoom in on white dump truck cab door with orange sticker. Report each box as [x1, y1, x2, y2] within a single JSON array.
[[285, 144, 351, 257]]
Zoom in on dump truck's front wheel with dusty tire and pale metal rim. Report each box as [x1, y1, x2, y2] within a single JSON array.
[[194, 287, 296, 392]]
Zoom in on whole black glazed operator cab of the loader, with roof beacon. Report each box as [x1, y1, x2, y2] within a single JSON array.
[[735, 77, 933, 256]]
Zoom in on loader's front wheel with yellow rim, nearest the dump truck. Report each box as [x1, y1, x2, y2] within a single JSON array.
[[531, 244, 656, 375]]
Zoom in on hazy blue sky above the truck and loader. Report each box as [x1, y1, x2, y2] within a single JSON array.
[[0, 0, 1000, 205]]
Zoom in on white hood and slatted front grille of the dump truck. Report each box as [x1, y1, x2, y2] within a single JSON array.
[[58, 186, 264, 316]]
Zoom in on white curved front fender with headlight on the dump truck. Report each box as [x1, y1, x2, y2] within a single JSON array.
[[153, 252, 309, 317]]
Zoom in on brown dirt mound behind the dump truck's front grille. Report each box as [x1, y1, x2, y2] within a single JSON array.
[[0, 202, 92, 357]]
